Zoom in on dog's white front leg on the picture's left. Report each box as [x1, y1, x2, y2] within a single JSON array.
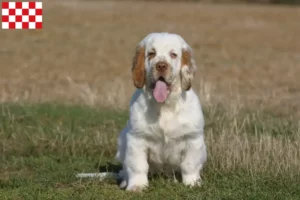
[[124, 134, 149, 191]]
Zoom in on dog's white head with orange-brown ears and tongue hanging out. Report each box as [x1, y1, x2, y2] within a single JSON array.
[[132, 33, 196, 102]]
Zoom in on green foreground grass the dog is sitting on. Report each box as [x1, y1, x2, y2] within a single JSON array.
[[0, 104, 300, 200]]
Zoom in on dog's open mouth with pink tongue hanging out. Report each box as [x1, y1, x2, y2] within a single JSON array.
[[151, 76, 170, 103]]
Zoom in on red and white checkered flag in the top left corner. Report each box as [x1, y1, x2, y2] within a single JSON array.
[[2, 1, 43, 29]]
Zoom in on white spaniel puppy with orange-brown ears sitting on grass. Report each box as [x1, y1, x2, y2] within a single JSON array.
[[116, 33, 207, 191]]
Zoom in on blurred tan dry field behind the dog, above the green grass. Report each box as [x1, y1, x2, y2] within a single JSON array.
[[0, 0, 300, 115]]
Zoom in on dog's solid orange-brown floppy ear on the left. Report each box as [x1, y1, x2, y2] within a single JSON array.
[[132, 45, 146, 88]]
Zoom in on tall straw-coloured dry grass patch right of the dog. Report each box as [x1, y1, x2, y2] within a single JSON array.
[[205, 105, 300, 177]]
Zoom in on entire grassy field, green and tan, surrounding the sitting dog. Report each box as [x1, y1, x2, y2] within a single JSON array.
[[0, 0, 300, 200]]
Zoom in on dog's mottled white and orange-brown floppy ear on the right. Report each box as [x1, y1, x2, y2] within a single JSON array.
[[181, 46, 196, 90]]
